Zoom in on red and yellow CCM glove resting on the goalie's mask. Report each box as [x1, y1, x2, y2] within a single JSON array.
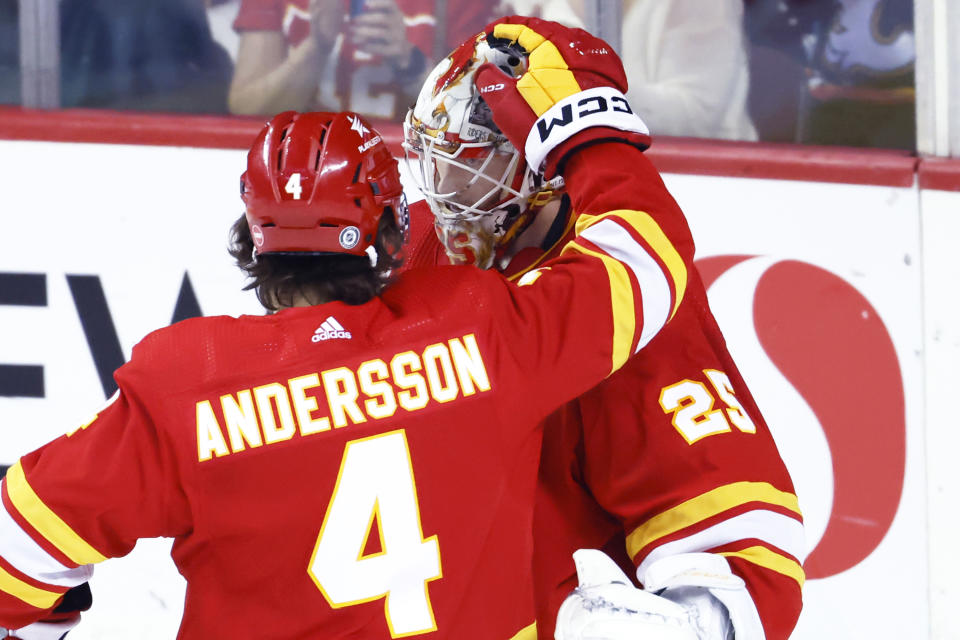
[[475, 16, 650, 178]]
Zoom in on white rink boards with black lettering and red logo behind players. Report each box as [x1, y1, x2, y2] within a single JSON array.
[[0, 120, 960, 640]]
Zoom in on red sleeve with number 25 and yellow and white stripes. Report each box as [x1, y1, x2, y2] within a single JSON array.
[[580, 292, 805, 640]]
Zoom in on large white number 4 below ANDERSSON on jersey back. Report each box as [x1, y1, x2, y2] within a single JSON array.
[[307, 430, 442, 638]]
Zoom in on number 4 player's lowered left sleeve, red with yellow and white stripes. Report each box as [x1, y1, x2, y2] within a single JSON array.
[[0, 364, 189, 629]]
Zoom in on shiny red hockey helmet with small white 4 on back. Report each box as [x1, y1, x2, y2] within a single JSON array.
[[240, 111, 409, 263]]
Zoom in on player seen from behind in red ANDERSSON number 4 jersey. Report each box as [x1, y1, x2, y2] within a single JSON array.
[[0, 37, 693, 640]]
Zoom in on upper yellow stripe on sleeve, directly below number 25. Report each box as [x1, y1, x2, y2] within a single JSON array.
[[627, 481, 800, 558]]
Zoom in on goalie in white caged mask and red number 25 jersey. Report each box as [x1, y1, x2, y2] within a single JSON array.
[[405, 16, 805, 640]]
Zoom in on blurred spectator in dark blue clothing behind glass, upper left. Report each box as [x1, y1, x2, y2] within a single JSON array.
[[60, 0, 232, 113]]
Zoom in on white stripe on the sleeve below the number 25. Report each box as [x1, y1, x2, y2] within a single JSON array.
[[637, 509, 806, 582]]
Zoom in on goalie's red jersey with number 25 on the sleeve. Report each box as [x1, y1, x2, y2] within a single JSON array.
[[411, 146, 805, 640]]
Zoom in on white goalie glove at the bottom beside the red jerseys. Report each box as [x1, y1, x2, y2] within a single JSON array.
[[554, 549, 733, 640]]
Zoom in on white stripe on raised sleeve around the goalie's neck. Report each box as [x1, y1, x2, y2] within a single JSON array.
[[580, 219, 671, 350]]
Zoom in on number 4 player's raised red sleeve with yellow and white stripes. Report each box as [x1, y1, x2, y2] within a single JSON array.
[[476, 137, 693, 417]]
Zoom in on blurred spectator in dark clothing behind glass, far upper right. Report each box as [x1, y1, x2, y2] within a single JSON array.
[[746, 0, 916, 150]]
